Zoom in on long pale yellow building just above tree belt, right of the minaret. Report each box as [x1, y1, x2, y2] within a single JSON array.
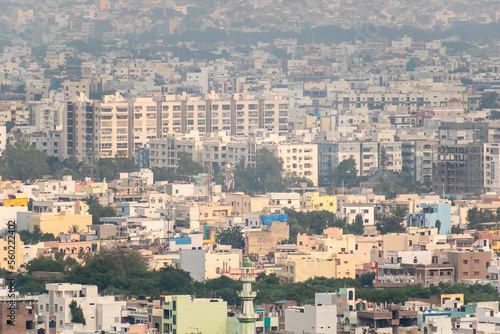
[[278, 252, 356, 283]]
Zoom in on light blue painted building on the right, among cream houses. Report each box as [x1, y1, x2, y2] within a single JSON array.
[[406, 203, 451, 234]]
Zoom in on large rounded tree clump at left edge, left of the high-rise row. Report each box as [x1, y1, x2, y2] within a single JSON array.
[[0, 141, 49, 181]]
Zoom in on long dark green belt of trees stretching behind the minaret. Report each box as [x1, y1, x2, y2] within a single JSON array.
[[4, 249, 500, 305]]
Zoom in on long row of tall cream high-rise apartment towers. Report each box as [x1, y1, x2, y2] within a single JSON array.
[[63, 93, 288, 164]]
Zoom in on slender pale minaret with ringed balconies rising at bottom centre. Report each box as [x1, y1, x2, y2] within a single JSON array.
[[237, 257, 259, 334]]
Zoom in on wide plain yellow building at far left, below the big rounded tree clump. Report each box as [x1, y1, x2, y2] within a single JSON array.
[[30, 211, 92, 236]]
